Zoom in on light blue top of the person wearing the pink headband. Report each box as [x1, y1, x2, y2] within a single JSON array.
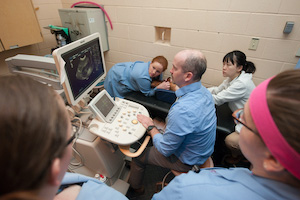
[[152, 168, 300, 200]]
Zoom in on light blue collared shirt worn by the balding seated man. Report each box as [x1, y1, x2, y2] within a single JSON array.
[[153, 82, 217, 165]]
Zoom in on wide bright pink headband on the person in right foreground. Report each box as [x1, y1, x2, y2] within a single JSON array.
[[249, 78, 300, 179]]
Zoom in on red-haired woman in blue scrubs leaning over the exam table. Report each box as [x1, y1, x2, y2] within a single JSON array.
[[104, 56, 170, 98]]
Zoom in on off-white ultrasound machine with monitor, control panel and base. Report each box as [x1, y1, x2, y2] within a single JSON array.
[[6, 33, 150, 194]]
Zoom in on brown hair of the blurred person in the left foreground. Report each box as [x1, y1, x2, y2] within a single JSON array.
[[0, 76, 69, 196]]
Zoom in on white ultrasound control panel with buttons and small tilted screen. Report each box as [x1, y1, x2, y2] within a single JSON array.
[[88, 90, 149, 146]]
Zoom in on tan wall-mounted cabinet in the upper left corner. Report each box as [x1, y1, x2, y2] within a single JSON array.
[[0, 0, 43, 51]]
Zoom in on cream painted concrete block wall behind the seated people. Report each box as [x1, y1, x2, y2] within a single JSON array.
[[61, 0, 300, 86]]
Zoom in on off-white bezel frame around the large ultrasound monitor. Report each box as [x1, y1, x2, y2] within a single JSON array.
[[52, 32, 106, 106]]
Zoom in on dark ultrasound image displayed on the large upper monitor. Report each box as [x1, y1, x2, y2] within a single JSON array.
[[62, 39, 104, 100]]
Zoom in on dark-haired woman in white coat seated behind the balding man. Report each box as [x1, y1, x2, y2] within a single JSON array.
[[208, 50, 256, 162]]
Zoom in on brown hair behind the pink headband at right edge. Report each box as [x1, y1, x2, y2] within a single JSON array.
[[267, 69, 300, 153]]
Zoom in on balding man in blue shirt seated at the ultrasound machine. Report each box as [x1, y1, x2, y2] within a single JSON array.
[[129, 50, 216, 192]]
